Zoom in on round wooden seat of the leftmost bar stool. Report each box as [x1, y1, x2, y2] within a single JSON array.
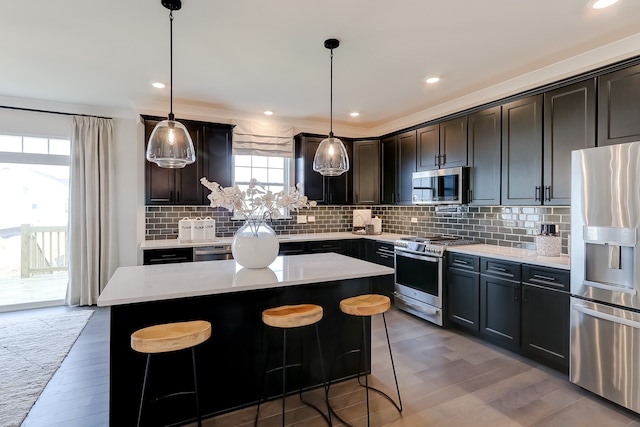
[[131, 320, 211, 353]]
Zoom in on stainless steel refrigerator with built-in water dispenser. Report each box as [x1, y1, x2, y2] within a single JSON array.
[[569, 142, 640, 412]]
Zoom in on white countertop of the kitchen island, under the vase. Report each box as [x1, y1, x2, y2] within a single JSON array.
[[98, 253, 394, 307]]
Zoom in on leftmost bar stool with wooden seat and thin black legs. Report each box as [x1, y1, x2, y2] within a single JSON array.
[[131, 320, 211, 426]]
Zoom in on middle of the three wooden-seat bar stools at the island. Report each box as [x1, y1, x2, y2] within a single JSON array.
[[254, 304, 331, 427]]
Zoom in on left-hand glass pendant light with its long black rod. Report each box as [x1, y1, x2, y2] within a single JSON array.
[[147, 0, 196, 169]]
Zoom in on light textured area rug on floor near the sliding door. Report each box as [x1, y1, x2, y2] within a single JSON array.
[[0, 310, 93, 427]]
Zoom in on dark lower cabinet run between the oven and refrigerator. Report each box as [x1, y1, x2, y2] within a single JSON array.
[[447, 252, 570, 373]]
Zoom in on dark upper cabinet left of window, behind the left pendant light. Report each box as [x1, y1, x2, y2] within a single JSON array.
[[143, 117, 232, 205]]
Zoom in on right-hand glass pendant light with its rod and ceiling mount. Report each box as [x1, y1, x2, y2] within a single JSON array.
[[313, 39, 349, 176]]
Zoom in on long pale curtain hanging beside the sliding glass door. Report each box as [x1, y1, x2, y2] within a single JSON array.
[[66, 116, 117, 305]]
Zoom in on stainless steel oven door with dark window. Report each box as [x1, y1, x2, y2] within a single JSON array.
[[396, 250, 442, 308]]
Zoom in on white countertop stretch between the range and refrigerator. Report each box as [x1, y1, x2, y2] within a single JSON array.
[[447, 244, 571, 270]]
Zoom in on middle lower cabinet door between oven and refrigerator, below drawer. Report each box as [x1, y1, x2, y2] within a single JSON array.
[[480, 274, 520, 350]]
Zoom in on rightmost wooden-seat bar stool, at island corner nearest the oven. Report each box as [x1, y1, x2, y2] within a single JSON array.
[[327, 294, 402, 426]]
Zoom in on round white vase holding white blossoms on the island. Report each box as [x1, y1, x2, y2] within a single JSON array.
[[231, 220, 280, 268]]
